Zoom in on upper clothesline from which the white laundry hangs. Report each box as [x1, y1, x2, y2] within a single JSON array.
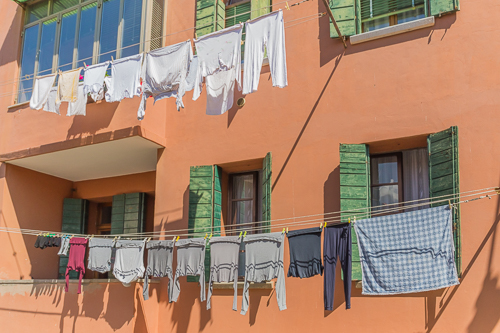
[[0, 0, 316, 94]]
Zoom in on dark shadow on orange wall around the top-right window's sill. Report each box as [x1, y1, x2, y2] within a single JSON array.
[[318, 1, 457, 67]]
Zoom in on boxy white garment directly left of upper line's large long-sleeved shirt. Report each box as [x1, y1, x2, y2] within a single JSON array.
[[105, 53, 143, 102]]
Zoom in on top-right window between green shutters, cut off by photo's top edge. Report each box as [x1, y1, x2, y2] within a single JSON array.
[[361, 0, 426, 32]]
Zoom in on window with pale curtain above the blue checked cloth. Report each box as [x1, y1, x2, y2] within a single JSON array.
[[370, 148, 429, 212]]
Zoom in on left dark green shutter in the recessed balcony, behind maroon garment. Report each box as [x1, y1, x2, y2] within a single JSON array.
[[58, 198, 88, 279]]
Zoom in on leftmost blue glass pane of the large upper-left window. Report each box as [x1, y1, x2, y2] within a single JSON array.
[[17, 24, 39, 103]]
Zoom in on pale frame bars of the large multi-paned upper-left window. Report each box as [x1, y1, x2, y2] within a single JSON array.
[[18, 0, 150, 103]]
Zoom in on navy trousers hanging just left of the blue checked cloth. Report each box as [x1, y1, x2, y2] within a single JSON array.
[[323, 223, 352, 311]]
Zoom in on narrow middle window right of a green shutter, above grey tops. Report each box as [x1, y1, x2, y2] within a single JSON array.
[[228, 171, 261, 233]]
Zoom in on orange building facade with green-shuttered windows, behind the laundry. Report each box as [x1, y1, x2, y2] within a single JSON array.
[[0, 0, 500, 332]]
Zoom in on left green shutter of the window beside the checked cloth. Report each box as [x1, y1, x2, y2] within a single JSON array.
[[339, 144, 371, 280]]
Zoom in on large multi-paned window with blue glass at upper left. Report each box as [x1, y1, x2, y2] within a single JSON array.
[[16, 0, 163, 103]]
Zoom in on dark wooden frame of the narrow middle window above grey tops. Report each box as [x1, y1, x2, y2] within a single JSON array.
[[225, 170, 261, 234]]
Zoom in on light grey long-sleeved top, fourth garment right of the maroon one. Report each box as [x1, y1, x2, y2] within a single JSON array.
[[169, 238, 205, 302]]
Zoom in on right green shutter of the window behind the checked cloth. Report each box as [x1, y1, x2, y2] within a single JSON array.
[[427, 126, 462, 276]]
